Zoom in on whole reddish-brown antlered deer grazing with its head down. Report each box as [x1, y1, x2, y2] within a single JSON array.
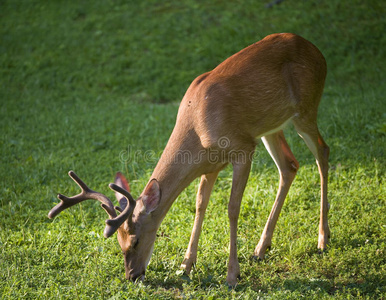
[[49, 33, 330, 286]]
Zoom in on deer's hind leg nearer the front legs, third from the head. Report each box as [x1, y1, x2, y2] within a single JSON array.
[[253, 131, 299, 259]]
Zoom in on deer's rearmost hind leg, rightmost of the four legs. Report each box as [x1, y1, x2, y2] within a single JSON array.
[[293, 119, 330, 250]]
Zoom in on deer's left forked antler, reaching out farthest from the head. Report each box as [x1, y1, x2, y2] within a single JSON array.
[[48, 171, 117, 219]]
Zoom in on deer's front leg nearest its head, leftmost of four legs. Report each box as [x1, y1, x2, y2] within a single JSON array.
[[181, 172, 218, 275]]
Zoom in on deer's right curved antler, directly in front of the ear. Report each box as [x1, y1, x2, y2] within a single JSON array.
[[102, 183, 136, 238]]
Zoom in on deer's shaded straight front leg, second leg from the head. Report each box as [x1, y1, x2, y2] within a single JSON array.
[[226, 158, 251, 286]]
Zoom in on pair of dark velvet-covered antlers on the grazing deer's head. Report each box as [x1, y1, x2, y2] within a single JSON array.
[[48, 171, 136, 238]]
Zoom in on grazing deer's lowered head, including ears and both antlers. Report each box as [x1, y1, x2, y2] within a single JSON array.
[[48, 171, 161, 281]]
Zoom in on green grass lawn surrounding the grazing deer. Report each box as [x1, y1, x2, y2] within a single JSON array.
[[0, 0, 386, 299]]
